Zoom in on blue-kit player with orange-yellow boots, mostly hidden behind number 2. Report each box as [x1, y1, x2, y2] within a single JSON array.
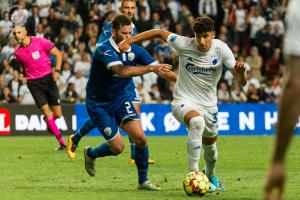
[[67, 0, 155, 164]]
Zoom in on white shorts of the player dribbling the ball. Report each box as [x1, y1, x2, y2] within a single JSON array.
[[172, 101, 218, 138]]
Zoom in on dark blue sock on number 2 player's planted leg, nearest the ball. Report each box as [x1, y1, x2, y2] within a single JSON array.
[[135, 146, 149, 184]]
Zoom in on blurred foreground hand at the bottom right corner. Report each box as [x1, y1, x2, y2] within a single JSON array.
[[264, 162, 285, 200]]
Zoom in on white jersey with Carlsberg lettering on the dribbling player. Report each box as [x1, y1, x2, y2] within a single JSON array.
[[167, 33, 236, 107]]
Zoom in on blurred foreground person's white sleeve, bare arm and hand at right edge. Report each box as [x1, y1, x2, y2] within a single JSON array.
[[264, 0, 300, 200]]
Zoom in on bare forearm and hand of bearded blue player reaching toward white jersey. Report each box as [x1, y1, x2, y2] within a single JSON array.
[[110, 64, 172, 78]]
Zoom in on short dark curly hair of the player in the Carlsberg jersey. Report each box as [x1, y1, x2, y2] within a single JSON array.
[[192, 16, 214, 34]]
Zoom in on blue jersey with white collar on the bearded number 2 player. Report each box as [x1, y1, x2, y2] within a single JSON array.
[[86, 38, 156, 102]]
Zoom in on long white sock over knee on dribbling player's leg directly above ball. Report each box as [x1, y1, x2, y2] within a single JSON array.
[[187, 116, 205, 171]]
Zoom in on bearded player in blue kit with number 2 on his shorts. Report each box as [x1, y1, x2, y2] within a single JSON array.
[[84, 15, 174, 190]]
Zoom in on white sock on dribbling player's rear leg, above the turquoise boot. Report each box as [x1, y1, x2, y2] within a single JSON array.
[[203, 142, 218, 178]]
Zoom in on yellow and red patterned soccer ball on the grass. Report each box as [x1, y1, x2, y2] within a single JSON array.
[[183, 171, 209, 196]]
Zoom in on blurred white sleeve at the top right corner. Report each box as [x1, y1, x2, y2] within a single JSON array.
[[284, 0, 300, 56]]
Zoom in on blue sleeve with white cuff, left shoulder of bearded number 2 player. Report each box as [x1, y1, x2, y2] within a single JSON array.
[[93, 45, 123, 70]]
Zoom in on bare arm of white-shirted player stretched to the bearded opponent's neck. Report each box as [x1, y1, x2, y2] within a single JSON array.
[[118, 29, 171, 52]]
